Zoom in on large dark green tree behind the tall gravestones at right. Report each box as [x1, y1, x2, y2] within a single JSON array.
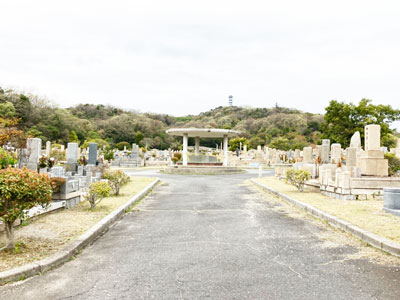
[[322, 99, 400, 148]]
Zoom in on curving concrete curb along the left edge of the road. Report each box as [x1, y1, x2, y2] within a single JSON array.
[[0, 178, 160, 285]]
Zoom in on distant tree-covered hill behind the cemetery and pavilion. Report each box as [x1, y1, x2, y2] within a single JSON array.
[[0, 88, 323, 149]]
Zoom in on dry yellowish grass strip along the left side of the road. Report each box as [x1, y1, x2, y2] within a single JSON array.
[[0, 176, 155, 272]]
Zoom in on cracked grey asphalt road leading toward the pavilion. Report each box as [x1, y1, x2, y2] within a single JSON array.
[[0, 171, 400, 300]]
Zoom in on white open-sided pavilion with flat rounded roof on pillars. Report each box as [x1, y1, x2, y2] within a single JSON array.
[[166, 128, 240, 167]]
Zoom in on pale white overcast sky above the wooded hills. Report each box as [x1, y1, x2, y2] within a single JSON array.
[[0, 0, 400, 115]]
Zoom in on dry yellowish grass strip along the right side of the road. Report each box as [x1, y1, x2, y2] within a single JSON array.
[[255, 177, 400, 243]]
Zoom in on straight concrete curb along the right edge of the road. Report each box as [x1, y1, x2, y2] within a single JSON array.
[[250, 179, 400, 257]]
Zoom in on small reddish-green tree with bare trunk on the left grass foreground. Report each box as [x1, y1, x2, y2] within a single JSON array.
[[0, 167, 52, 249]]
